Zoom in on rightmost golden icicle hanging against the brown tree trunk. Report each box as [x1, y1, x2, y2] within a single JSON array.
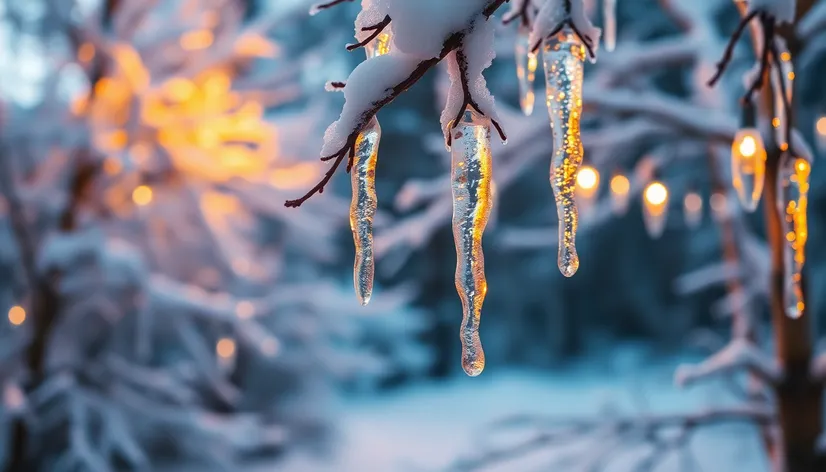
[[777, 155, 811, 318]]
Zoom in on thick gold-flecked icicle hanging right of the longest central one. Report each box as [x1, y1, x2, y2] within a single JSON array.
[[543, 27, 585, 277]]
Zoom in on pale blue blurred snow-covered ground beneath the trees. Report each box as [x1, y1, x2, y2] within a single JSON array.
[[278, 346, 767, 472]]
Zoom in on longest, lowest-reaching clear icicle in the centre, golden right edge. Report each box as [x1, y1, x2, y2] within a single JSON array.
[[451, 110, 492, 376]]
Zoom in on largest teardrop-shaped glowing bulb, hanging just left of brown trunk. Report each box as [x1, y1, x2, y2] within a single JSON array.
[[731, 128, 766, 212]]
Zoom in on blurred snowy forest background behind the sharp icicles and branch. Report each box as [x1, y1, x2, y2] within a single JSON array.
[[0, 0, 826, 472]]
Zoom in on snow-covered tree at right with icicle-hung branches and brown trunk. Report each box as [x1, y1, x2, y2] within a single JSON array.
[[286, 0, 824, 471]]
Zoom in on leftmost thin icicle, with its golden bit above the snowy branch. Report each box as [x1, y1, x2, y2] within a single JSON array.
[[350, 33, 390, 305]]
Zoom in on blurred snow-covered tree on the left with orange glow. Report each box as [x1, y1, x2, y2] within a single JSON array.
[[0, 0, 427, 471]]
